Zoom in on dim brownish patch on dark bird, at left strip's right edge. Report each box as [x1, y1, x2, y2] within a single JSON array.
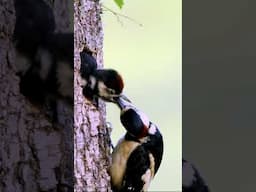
[[57, 62, 74, 97]]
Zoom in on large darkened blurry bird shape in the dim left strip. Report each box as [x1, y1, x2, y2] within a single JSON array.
[[13, 0, 74, 121]]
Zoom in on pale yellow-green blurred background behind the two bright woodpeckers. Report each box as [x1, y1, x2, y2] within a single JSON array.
[[102, 0, 182, 191]]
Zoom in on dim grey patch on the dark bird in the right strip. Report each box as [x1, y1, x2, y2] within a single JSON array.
[[182, 162, 195, 187]]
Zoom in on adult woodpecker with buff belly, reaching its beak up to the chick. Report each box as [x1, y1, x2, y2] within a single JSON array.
[[109, 95, 163, 192]]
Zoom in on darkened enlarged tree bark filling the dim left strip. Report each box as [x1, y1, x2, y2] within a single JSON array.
[[0, 0, 73, 192]]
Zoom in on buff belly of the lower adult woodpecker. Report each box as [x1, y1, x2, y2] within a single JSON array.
[[110, 138, 140, 189]]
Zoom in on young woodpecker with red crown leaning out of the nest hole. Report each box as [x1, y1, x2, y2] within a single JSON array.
[[80, 50, 124, 103]]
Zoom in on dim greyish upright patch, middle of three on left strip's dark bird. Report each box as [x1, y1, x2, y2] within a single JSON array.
[[36, 48, 52, 80]]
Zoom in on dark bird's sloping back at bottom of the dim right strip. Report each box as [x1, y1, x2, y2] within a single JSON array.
[[182, 159, 210, 192]]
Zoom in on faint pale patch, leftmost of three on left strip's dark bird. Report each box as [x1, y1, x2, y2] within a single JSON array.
[[15, 51, 31, 75]]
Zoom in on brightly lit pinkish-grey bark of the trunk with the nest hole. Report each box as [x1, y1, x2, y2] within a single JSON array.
[[74, 0, 111, 192]]
